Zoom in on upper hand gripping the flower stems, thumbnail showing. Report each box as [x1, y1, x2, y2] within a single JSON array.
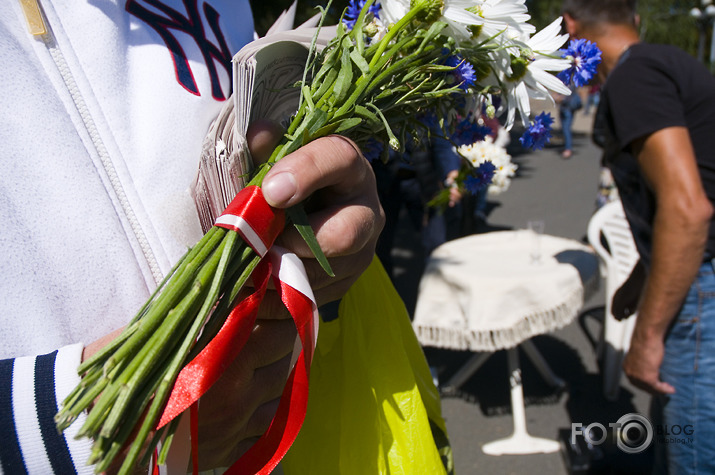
[[248, 119, 385, 305]]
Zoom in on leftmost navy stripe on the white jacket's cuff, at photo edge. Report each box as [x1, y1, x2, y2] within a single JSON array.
[[0, 359, 27, 475]]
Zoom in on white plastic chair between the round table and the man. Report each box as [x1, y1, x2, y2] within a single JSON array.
[[588, 200, 638, 401]]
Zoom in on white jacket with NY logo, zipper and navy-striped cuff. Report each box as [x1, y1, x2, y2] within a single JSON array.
[[0, 0, 253, 473]]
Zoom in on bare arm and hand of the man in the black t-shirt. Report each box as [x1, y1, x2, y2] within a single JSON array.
[[623, 127, 713, 393]]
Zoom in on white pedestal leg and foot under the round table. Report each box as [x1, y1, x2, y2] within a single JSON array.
[[482, 347, 561, 455]]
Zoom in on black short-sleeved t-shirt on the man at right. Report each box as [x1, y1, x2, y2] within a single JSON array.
[[594, 43, 715, 267]]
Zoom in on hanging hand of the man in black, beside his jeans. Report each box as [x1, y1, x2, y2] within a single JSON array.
[[623, 329, 675, 394]]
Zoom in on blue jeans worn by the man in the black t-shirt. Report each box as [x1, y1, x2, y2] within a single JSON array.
[[653, 262, 715, 475]]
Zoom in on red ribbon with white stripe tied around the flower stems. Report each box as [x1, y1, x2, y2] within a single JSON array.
[[157, 187, 317, 475]]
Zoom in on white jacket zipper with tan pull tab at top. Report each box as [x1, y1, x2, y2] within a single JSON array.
[[20, 0, 163, 285]]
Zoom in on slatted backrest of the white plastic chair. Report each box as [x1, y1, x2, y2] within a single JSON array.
[[588, 200, 638, 292]]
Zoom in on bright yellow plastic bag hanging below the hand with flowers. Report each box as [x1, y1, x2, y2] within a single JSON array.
[[282, 258, 453, 475]]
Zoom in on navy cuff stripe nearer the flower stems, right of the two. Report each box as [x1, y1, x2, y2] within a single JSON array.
[[35, 351, 77, 474]]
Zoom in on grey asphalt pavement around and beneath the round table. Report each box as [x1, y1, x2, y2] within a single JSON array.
[[393, 106, 653, 475]]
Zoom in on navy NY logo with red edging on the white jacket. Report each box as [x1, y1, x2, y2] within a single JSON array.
[[126, 0, 231, 101]]
